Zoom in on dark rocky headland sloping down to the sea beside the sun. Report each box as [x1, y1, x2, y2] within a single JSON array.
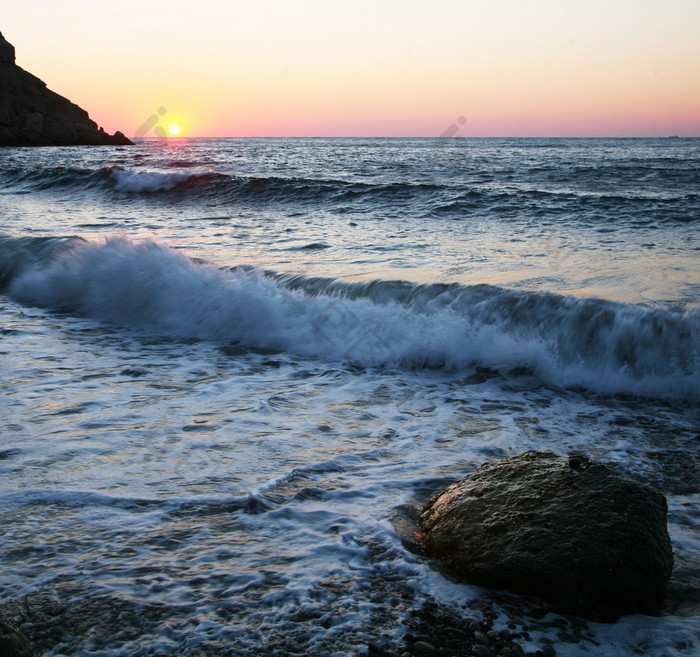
[[0, 34, 133, 146]]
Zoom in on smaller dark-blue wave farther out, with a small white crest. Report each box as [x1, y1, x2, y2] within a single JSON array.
[[0, 166, 700, 222]]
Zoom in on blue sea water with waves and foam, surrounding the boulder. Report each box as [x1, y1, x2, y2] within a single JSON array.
[[0, 139, 700, 657]]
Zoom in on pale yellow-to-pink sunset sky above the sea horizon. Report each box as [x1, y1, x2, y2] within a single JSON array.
[[0, 0, 700, 137]]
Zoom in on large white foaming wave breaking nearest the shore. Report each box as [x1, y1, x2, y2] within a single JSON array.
[[0, 236, 700, 400]]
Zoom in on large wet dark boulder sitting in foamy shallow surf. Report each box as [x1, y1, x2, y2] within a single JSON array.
[[418, 451, 673, 621]]
